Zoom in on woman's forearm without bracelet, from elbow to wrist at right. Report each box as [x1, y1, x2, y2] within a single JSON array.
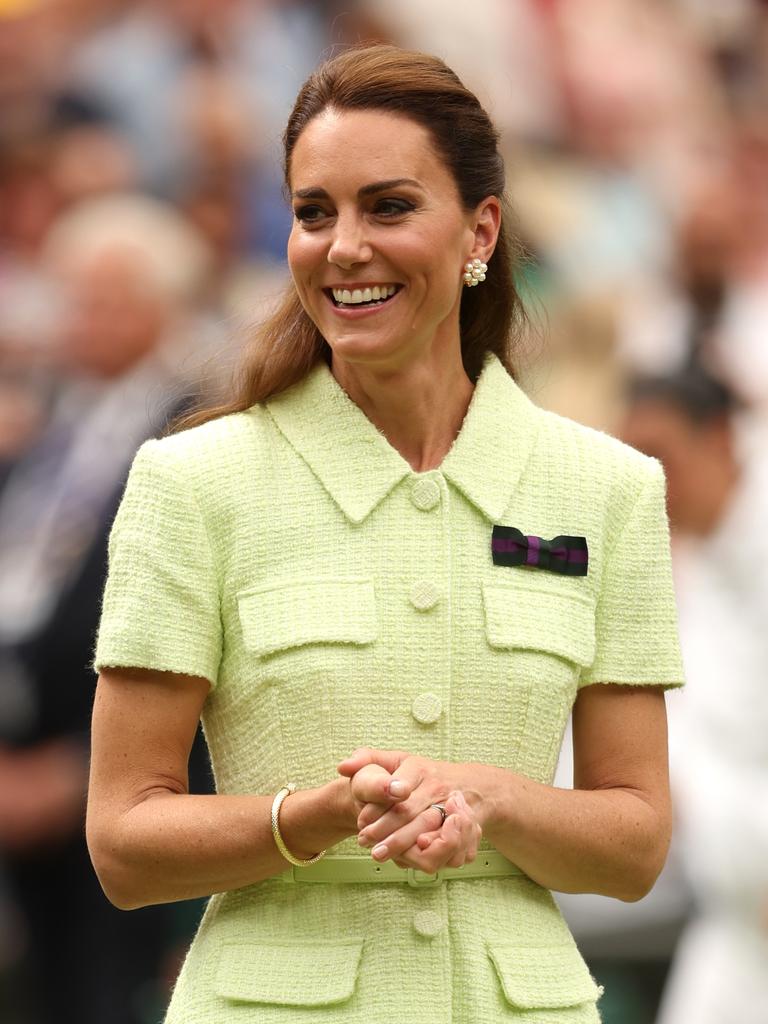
[[465, 764, 671, 900]]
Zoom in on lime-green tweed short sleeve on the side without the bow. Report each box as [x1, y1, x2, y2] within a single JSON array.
[[93, 440, 222, 686]]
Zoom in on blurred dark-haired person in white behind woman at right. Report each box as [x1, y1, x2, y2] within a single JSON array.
[[622, 361, 768, 1024]]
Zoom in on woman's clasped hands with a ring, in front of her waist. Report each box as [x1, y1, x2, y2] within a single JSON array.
[[337, 748, 482, 874]]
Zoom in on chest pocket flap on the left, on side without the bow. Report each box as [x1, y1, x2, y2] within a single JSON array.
[[238, 577, 378, 654]]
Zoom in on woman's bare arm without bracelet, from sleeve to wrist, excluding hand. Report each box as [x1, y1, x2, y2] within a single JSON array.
[[485, 684, 672, 900]]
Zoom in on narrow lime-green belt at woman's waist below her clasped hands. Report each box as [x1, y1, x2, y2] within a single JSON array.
[[280, 850, 524, 889]]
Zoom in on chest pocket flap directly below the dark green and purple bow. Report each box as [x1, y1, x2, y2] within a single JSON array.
[[482, 581, 595, 666]]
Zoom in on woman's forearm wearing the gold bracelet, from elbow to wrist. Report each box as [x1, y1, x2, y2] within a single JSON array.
[[88, 779, 356, 909]]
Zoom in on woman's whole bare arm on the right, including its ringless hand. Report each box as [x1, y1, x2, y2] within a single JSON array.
[[339, 685, 672, 901]]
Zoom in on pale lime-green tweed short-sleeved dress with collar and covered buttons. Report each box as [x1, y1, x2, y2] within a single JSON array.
[[94, 355, 683, 1024]]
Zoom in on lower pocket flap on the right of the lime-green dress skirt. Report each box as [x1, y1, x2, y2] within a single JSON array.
[[487, 942, 602, 1010]]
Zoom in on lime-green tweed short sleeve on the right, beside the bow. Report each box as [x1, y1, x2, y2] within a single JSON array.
[[580, 459, 685, 687]]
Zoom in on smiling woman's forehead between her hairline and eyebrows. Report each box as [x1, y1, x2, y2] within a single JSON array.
[[290, 109, 456, 193]]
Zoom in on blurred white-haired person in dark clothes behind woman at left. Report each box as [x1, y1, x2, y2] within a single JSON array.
[[0, 194, 219, 1024]]
